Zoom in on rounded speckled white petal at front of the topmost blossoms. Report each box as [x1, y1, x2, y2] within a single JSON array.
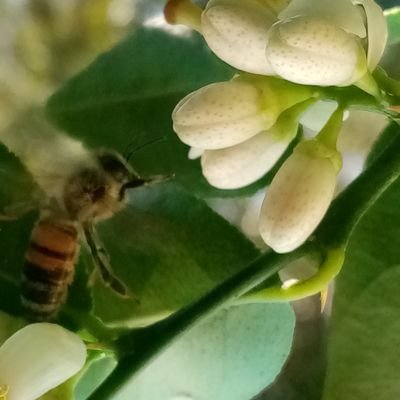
[[267, 17, 366, 86]]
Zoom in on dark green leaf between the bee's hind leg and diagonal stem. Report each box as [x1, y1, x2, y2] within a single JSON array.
[[93, 183, 259, 327]]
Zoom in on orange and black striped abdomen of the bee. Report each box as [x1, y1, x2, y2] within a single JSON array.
[[21, 219, 79, 321]]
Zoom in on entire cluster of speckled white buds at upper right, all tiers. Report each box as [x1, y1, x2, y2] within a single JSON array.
[[166, 0, 387, 252]]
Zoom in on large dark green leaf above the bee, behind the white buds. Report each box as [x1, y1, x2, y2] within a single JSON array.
[[47, 25, 272, 197]]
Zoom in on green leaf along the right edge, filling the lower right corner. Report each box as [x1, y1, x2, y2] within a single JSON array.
[[323, 177, 400, 400]]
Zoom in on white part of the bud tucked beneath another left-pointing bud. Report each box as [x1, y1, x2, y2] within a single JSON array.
[[201, 132, 291, 189]]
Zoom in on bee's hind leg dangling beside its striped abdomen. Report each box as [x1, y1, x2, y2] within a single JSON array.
[[83, 223, 139, 298]]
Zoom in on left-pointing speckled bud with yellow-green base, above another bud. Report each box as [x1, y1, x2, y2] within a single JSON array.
[[172, 74, 314, 150]]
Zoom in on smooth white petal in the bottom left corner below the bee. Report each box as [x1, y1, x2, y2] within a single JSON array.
[[0, 323, 86, 400]]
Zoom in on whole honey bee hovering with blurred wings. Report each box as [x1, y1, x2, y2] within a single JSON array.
[[3, 128, 165, 321]]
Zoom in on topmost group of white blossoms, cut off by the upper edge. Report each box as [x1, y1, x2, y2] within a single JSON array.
[[166, 0, 387, 90]]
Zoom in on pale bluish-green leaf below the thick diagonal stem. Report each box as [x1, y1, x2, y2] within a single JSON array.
[[113, 304, 294, 400]]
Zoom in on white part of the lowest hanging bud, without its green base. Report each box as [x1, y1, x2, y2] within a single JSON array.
[[260, 150, 336, 253]]
